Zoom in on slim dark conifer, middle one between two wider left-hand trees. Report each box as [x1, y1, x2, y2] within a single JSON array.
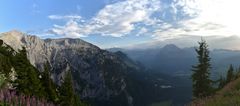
[[41, 62, 58, 102]]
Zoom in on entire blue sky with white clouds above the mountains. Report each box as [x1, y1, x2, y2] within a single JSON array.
[[0, 0, 240, 49]]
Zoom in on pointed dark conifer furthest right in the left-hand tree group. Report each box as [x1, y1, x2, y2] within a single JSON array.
[[60, 71, 75, 106]]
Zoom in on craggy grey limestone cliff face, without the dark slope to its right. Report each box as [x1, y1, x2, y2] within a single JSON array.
[[0, 31, 131, 104]]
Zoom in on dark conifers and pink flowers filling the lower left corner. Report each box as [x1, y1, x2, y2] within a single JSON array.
[[0, 40, 86, 106]]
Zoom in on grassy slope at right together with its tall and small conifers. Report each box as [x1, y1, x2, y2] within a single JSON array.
[[189, 40, 240, 106]]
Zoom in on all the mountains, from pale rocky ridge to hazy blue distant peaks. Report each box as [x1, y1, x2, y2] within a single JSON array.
[[3, 31, 240, 106]]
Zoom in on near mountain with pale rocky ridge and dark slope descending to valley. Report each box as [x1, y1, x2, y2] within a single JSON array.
[[0, 31, 191, 106]]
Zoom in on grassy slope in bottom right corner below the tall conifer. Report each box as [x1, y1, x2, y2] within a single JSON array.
[[190, 78, 240, 106]]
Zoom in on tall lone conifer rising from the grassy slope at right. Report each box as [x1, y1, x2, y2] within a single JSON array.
[[192, 39, 212, 98]]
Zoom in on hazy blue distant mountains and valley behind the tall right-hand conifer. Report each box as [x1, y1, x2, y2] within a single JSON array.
[[108, 44, 240, 77]]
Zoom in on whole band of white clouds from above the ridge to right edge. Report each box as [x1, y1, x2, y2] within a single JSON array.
[[48, 0, 240, 40]]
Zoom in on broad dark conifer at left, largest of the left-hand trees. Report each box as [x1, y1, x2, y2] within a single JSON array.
[[12, 48, 45, 98]]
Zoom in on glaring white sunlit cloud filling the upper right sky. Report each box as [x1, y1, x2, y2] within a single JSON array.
[[155, 0, 240, 40]]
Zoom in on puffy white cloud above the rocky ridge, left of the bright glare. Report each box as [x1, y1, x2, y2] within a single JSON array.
[[49, 0, 160, 37]]
